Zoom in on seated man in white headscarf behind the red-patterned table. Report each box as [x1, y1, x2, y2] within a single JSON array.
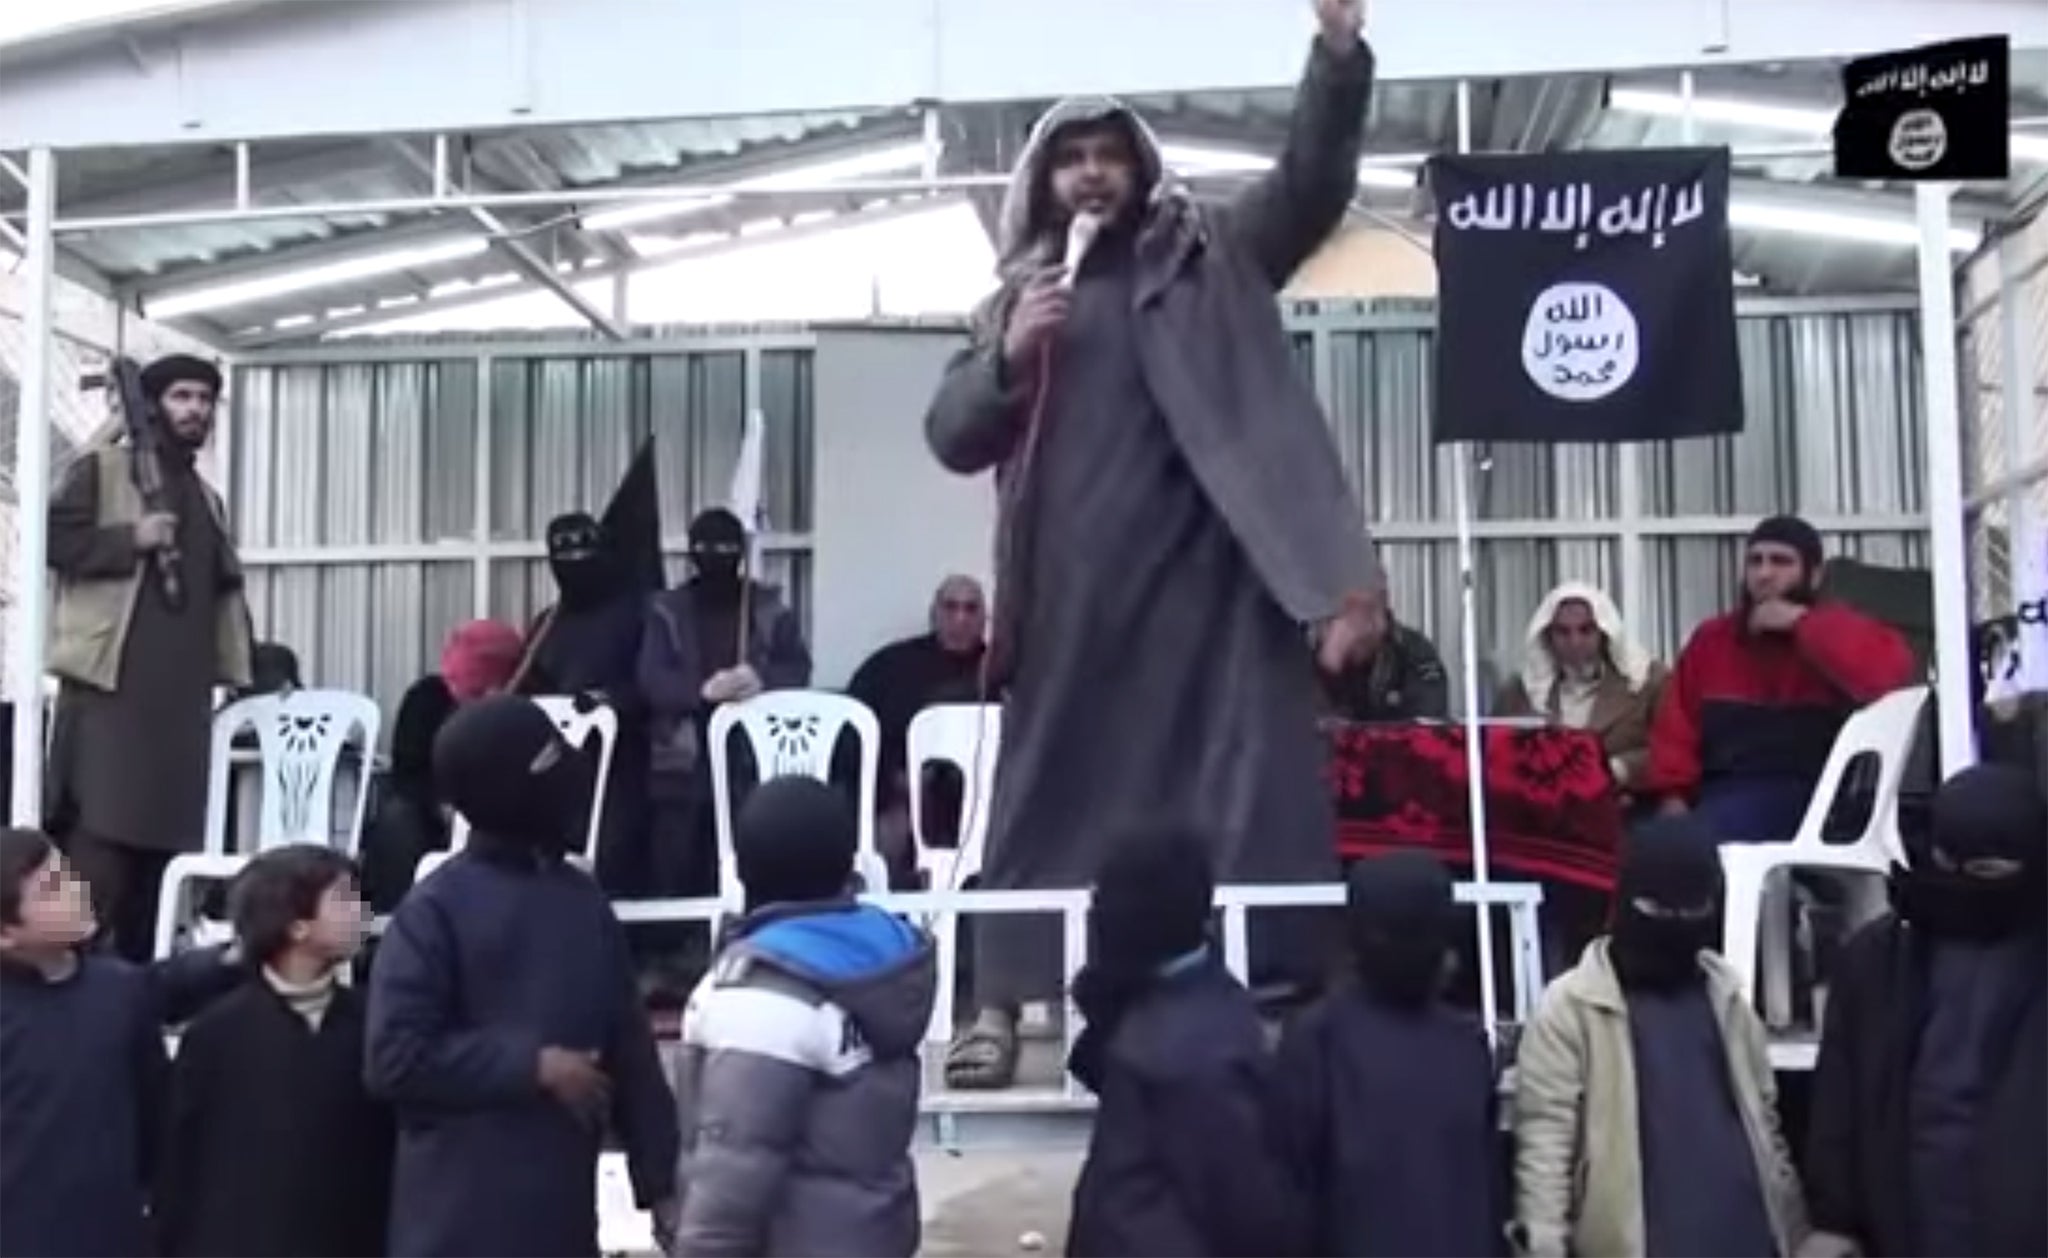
[[1493, 582, 1665, 791]]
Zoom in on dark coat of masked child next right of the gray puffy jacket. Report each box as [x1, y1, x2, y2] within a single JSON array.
[[1067, 961, 1303, 1258]]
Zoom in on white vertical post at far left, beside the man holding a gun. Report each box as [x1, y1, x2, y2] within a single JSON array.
[[8, 148, 57, 826]]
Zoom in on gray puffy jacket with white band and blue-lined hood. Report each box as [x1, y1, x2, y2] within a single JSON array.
[[674, 901, 936, 1258]]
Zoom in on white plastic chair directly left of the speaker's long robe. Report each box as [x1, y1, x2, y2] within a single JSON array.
[[903, 703, 1004, 1041]]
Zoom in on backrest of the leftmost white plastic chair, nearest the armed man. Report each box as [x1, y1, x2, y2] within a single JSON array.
[[205, 690, 383, 854]]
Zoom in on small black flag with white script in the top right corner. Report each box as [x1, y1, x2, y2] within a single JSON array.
[[1835, 35, 2013, 182]]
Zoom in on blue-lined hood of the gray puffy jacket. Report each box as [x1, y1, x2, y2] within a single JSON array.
[[735, 904, 938, 1057]]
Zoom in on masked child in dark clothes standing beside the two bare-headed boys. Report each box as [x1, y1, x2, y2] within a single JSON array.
[[365, 695, 680, 1256]]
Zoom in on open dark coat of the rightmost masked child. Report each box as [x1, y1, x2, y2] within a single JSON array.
[[1804, 916, 2048, 1258]]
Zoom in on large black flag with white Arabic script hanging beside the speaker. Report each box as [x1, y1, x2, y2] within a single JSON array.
[[1430, 148, 1743, 443]]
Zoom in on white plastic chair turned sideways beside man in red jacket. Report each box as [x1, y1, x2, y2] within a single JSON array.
[[1720, 686, 1927, 1026]]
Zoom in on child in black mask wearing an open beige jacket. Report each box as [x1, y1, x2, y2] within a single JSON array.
[[1516, 817, 1806, 1258]]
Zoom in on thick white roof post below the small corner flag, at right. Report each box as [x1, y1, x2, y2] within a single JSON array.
[[1913, 184, 1976, 777]]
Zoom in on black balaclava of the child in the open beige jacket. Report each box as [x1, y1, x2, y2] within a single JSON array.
[[1608, 817, 1720, 990]]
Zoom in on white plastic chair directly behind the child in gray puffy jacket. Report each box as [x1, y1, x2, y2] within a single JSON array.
[[709, 690, 889, 912]]
